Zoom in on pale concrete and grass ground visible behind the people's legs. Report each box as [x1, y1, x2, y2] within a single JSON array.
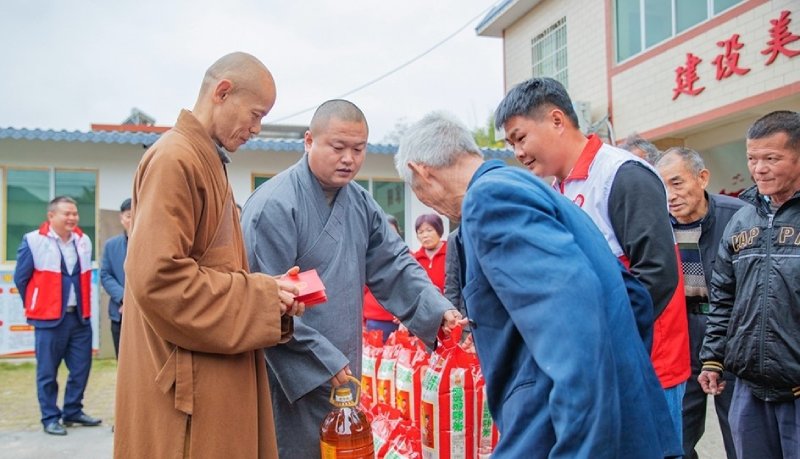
[[0, 360, 725, 459]]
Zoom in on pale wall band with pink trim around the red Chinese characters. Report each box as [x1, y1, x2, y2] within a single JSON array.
[[609, 0, 800, 144]]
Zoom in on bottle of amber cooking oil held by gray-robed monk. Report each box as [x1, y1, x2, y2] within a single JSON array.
[[319, 376, 375, 459]]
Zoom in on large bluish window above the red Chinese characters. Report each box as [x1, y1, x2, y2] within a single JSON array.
[[614, 0, 743, 62]]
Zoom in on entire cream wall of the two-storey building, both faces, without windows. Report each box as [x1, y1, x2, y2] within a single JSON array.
[[488, 0, 800, 193]]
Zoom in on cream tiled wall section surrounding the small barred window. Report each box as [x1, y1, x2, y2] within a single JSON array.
[[498, 0, 608, 125]]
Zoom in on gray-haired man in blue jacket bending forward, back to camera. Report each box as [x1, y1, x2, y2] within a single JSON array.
[[395, 113, 682, 459]]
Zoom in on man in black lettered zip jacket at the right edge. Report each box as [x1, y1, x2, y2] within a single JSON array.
[[698, 111, 800, 459]]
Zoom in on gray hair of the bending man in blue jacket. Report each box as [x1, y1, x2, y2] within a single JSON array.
[[394, 112, 483, 184]]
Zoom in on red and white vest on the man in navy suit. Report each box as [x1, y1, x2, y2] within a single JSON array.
[[24, 222, 92, 320]]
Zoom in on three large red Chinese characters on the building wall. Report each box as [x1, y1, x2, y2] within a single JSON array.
[[672, 11, 800, 100]]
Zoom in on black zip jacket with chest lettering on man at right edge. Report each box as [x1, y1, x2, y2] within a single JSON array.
[[700, 186, 800, 401]]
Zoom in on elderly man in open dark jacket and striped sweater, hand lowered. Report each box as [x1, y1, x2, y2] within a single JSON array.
[[655, 147, 745, 459]]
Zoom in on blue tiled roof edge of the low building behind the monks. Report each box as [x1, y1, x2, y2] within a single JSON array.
[[0, 128, 513, 158]]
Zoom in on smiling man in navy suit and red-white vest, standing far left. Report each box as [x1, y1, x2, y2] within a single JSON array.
[[14, 196, 101, 435]]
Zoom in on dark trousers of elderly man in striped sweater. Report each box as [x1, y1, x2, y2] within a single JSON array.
[[683, 313, 736, 459]]
